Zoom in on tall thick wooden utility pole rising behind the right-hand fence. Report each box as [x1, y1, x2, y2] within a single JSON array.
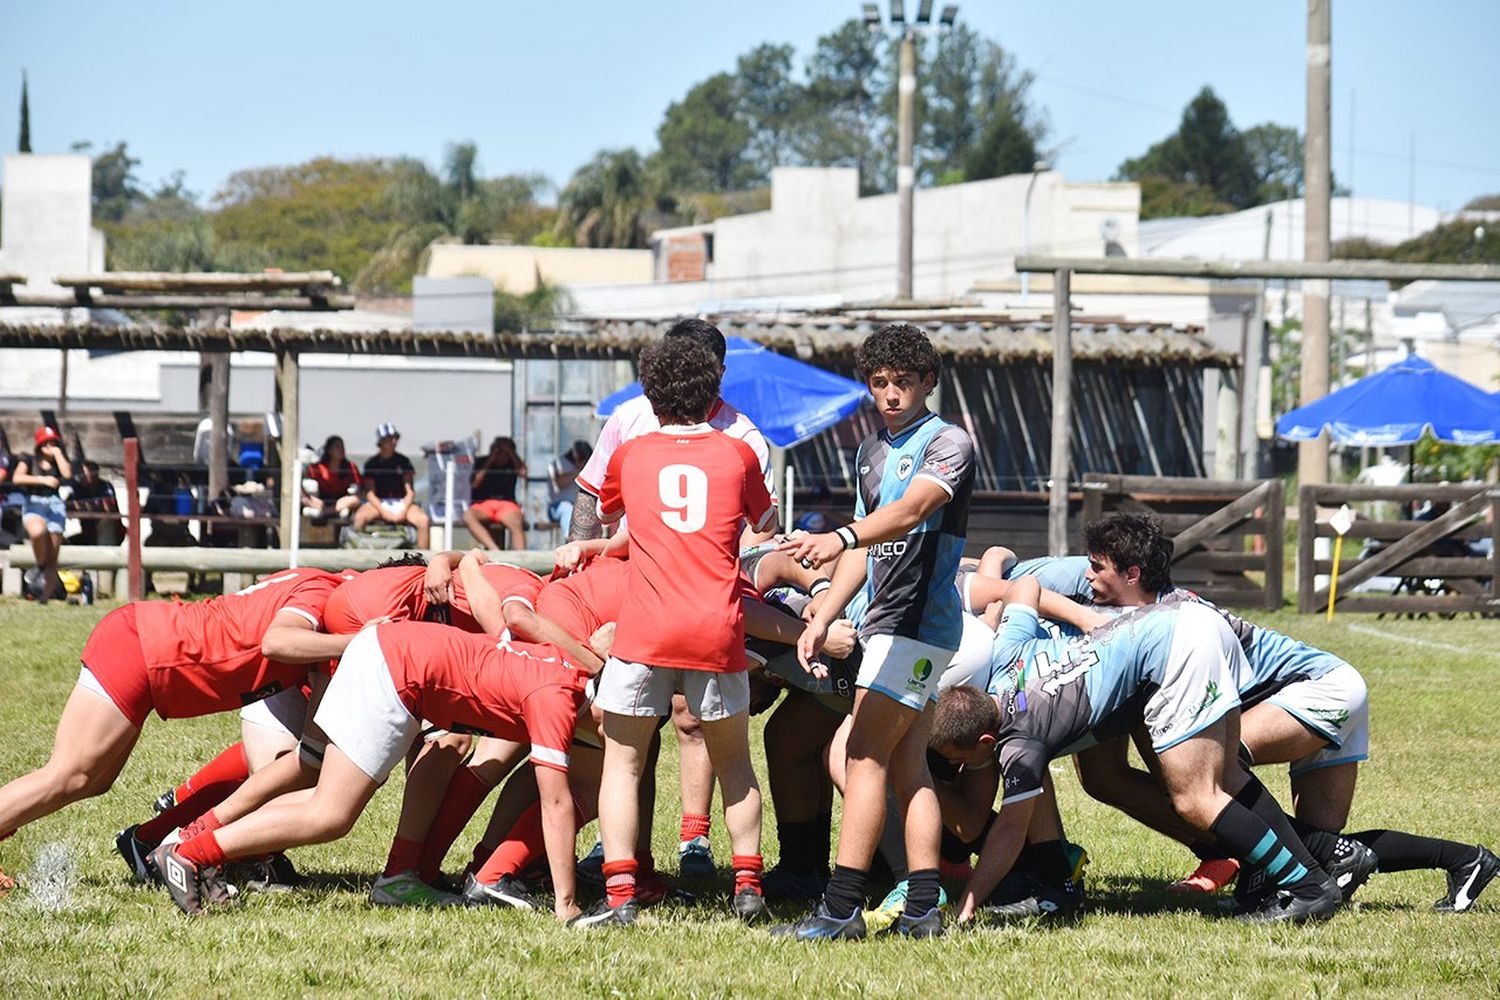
[[1298, 0, 1334, 484]]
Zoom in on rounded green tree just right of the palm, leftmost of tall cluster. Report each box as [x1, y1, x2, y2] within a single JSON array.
[[656, 73, 753, 190]]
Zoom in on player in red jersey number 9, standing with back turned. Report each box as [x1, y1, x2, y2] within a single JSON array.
[[575, 337, 776, 927]]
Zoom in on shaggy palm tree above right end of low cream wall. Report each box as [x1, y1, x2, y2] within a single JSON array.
[[554, 148, 663, 247]]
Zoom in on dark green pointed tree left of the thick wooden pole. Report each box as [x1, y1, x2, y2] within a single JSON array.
[[1116, 87, 1260, 219]]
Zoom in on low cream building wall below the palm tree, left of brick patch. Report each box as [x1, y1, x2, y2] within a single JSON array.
[[428, 243, 653, 295]]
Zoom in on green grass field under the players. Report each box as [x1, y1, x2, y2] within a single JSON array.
[[0, 601, 1500, 997]]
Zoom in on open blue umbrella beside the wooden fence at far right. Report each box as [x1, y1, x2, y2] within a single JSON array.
[[1277, 354, 1500, 448]]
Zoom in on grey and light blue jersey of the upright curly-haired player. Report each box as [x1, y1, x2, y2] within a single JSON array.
[[855, 414, 974, 649]]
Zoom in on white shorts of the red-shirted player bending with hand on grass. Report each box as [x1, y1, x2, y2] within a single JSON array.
[[312, 628, 422, 783]]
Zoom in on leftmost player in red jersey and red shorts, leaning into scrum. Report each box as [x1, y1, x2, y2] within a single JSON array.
[[0, 570, 350, 893]]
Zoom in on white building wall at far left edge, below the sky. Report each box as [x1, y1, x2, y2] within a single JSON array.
[[0, 153, 104, 294]]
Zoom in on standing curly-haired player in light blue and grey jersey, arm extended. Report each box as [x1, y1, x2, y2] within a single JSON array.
[[779, 324, 974, 940]]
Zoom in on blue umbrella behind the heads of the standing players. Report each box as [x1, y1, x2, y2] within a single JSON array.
[[599, 337, 869, 448]]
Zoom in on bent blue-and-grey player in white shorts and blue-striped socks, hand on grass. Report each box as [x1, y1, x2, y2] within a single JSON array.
[[932, 579, 1343, 922]]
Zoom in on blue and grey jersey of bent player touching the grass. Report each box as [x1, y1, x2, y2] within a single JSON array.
[[990, 604, 1179, 802]]
